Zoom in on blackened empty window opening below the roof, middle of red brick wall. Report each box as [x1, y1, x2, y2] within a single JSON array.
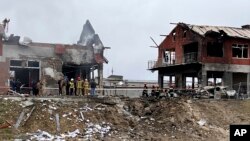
[[207, 42, 223, 57]]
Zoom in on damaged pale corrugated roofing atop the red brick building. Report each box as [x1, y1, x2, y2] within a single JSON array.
[[179, 23, 250, 39]]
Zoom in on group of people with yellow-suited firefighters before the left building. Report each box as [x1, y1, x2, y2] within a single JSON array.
[[58, 77, 97, 96]]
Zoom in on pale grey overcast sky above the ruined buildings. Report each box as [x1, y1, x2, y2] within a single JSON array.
[[0, 0, 250, 80]]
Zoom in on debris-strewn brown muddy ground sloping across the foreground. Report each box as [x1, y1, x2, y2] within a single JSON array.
[[0, 97, 250, 141]]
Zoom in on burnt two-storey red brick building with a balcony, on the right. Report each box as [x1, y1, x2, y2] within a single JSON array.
[[148, 23, 250, 93]]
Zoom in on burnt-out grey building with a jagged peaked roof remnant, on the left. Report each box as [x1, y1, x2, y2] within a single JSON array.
[[0, 20, 108, 94]]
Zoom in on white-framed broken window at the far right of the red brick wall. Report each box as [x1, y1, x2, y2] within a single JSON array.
[[232, 44, 248, 58]]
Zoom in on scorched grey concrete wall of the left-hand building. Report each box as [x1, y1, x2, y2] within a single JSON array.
[[0, 42, 95, 92]]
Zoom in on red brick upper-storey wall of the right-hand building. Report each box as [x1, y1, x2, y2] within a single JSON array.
[[158, 25, 250, 65]]
